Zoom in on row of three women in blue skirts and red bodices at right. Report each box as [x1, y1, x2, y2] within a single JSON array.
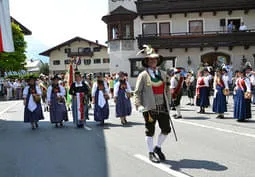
[[195, 63, 254, 121]]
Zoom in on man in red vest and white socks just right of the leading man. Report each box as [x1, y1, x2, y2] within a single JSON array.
[[167, 68, 186, 119]]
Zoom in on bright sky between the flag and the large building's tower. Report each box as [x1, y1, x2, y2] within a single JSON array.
[[9, 0, 108, 62]]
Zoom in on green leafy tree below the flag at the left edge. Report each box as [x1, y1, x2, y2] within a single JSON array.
[[0, 23, 27, 72]]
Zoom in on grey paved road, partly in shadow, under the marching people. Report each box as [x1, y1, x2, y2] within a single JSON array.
[[0, 97, 255, 177]]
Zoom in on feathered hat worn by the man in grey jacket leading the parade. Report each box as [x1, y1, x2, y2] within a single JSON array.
[[137, 45, 163, 68]]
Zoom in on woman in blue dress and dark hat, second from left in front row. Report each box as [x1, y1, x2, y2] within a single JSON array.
[[47, 75, 68, 128]]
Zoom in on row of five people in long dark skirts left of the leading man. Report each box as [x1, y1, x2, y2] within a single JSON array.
[[23, 72, 132, 130]]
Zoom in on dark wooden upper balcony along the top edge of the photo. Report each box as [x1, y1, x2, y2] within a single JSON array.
[[136, 0, 255, 16]]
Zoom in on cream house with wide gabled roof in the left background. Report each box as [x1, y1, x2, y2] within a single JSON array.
[[40, 37, 110, 75]]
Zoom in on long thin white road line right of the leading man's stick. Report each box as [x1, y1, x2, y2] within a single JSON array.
[[174, 120, 255, 138]]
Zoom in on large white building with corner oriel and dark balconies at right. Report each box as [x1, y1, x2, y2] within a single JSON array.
[[102, 0, 255, 86]]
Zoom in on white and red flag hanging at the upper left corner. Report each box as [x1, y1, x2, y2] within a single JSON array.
[[0, 0, 14, 52]]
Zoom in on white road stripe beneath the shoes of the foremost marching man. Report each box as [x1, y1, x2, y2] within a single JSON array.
[[134, 154, 190, 177]]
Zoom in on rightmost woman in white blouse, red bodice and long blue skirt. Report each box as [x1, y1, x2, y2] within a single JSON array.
[[234, 69, 251, 122]]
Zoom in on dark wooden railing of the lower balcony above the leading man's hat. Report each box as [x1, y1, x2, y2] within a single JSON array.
[[137, 29, 255, 49]]
